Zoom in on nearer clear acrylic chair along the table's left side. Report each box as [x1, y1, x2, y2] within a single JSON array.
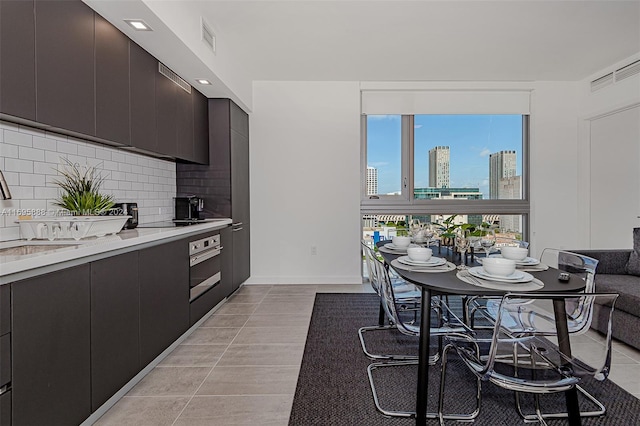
[[367, 255, 480, 420]]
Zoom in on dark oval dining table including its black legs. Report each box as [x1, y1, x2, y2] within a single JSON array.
[[376, 240, 585, 426]]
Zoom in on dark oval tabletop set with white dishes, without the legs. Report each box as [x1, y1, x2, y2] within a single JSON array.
[[376, 241, 585, 296]]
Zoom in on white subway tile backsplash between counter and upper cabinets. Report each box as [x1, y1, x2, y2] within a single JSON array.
[[0, 120, 176, 241]]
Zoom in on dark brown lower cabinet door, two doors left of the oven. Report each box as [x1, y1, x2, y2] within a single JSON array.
[[91, 252, 140, 411]]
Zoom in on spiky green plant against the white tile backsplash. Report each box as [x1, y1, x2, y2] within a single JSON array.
[[54, 158, 114, 216]]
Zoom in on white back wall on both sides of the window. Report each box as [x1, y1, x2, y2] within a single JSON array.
[[249, 82, 579, 283]]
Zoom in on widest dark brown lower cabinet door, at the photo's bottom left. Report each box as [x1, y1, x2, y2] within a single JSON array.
[[11, 264, 91, 426]]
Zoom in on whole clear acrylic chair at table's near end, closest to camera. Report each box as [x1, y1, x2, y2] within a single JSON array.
[[439, 293, 618, 424]]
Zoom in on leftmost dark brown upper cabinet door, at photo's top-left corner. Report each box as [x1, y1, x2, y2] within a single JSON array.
[[0, 0, 36, 120]]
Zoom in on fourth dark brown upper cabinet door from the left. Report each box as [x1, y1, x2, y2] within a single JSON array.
[[129, 41, 158, 152]]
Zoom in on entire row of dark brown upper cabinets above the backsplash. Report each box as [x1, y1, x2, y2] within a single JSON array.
[[0, 0, 209, 164]]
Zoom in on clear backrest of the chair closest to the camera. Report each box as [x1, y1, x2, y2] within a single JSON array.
[[485, 293, 618, 388]]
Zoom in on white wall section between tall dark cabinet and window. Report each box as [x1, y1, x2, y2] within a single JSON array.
[[248, 82, 362, 284]]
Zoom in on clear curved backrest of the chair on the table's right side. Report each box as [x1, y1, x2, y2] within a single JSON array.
[[540, 248, 598, 332]]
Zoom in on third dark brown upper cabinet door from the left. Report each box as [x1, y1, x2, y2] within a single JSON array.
[[95, 14, 131, 145]]
